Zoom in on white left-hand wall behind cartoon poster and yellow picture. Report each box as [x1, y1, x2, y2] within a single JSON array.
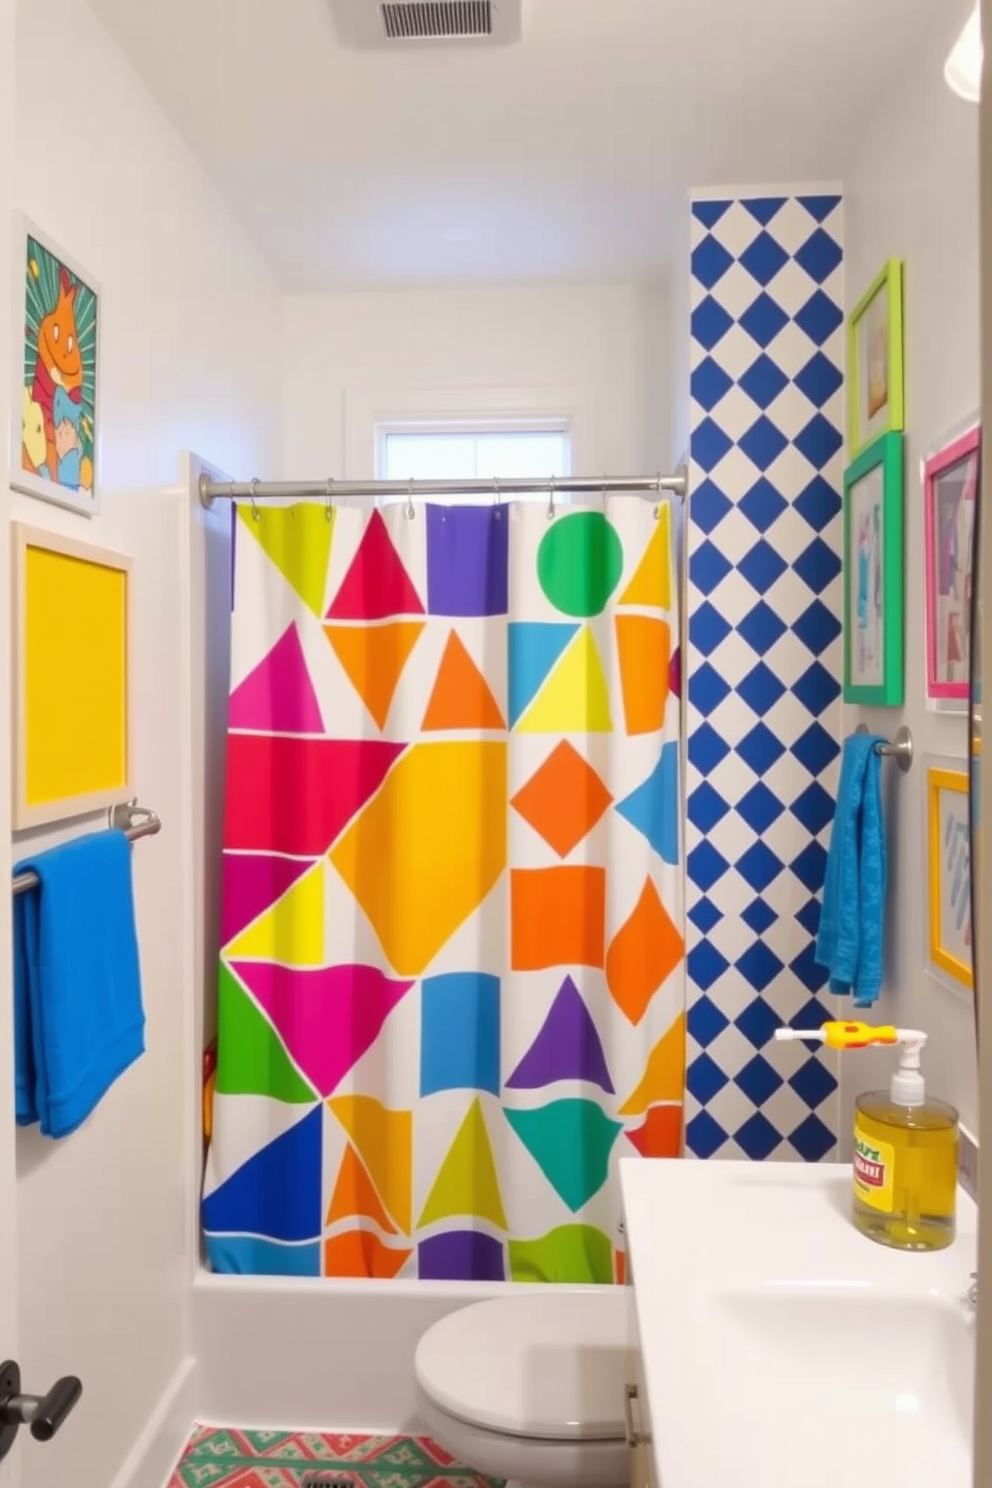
[[9, 0, 283, 1488]]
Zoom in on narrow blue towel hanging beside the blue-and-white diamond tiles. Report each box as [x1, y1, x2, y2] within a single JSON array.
[[817, 734, 886, 1007]]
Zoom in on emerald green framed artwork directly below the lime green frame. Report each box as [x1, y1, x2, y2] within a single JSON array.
[[843, 434, 904, 708]]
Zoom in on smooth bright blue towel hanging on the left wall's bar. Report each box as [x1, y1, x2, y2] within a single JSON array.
[[13, 832, 144, 1137]]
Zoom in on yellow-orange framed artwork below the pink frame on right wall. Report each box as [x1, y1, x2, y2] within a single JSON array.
[[927, 762, 974, 991]]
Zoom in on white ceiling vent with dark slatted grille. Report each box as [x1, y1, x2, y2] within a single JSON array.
[[330, 0, 524, 51]]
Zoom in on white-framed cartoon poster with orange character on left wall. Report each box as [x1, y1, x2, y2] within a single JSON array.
[[10, 217, 100, 516]]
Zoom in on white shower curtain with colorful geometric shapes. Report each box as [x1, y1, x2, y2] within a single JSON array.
[[202, 497, 684, 1283]]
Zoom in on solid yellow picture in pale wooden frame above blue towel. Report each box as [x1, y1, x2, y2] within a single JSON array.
[[12, 522, 132, 832]]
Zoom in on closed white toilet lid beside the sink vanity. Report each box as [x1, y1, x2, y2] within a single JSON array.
[[415, 1287, 626, 1440]]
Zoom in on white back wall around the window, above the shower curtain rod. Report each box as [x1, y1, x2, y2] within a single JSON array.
[[284, 284, 671, 481]]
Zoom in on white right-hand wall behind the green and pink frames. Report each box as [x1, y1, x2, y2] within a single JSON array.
[[843, 0, 979, 1131]]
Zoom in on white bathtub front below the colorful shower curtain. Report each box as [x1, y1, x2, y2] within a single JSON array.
[[190, 1269, 607, 1433]]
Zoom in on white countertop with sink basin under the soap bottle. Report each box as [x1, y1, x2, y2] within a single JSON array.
[[620, 1158, 977, 1488]]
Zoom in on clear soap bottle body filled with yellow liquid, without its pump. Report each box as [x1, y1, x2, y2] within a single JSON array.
[[854, 1091, 958, 1250]]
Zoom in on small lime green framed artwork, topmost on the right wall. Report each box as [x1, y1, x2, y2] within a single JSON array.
[[848, 259, 906, 458]]
